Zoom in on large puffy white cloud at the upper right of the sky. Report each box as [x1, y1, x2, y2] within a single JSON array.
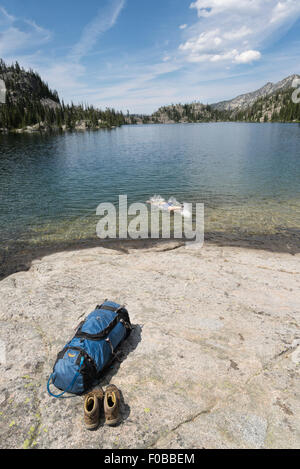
[[179, 0, 300, 64]]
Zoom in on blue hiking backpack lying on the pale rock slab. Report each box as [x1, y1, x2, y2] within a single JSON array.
[[47, 301, 132, 397]]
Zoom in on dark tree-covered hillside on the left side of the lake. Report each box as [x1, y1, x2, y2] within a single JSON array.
[[0, 59, 125, 133]]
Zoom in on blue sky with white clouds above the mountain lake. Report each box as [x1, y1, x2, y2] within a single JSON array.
[[0, 0, 300, 114]]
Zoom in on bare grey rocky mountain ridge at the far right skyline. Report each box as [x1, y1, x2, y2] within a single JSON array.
[[211, 75, 300, 111]]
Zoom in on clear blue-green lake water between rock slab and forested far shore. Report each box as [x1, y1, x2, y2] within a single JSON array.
[[0, 123, 300, 266]]
